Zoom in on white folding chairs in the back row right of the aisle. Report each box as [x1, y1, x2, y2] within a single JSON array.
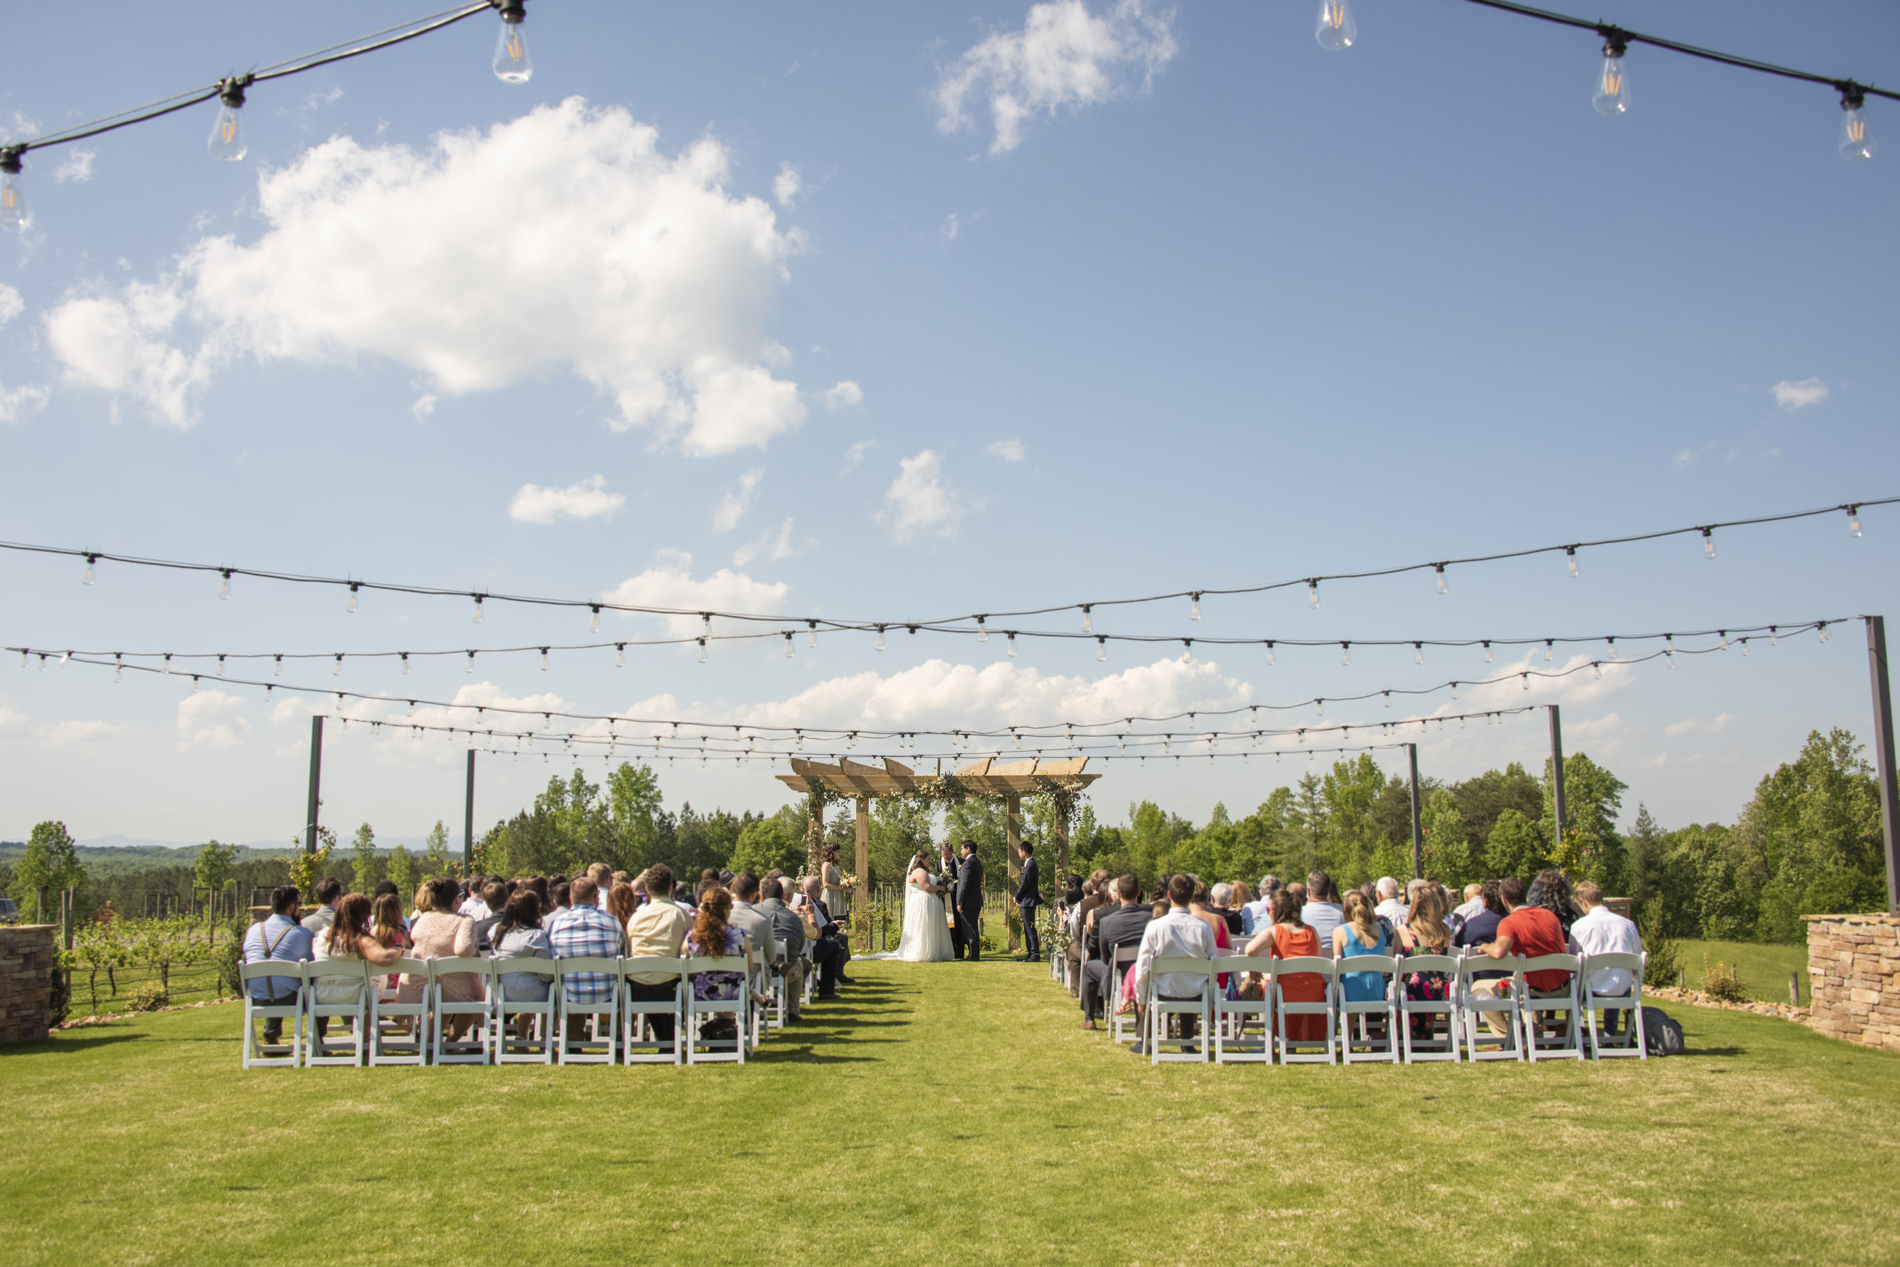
[[1112, 946, 1649, 1064]]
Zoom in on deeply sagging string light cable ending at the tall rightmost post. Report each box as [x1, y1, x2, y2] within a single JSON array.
[[6, 617, 1831, 750]]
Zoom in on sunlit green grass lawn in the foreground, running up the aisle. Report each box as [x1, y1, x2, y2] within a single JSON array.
[[0, 959, 1900, 1267]]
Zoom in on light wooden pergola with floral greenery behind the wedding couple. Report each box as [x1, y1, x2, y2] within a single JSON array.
[[779, 756, 1102, 923]]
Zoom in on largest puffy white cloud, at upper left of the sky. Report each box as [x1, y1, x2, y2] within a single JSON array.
[[48, 99, 806, 456]]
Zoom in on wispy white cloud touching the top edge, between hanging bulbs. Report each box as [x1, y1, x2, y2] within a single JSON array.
[[937, 0, 1176, 154]]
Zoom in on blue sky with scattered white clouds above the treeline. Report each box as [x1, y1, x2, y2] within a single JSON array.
[[0, 0, 1900, 840]]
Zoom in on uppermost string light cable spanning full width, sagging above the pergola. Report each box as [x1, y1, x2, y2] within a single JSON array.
[[0, 498, 1900, 650]]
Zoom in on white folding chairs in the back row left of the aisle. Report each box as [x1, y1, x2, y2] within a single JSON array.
[[241, 940, 813, 1069]]
